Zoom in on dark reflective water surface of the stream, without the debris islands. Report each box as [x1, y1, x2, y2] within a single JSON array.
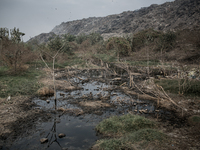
[[6, 71, 170, 150]]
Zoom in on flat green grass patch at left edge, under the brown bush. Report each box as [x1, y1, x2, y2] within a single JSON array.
[[0, 69, 42, 98]]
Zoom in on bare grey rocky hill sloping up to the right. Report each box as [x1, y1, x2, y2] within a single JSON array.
[[27, 0, 200, 43]]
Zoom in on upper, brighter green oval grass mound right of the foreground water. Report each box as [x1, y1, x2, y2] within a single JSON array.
[[96, 114, 155, 135]]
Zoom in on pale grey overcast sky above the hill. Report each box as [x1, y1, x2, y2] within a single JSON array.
[[0, 0, 174, 41]]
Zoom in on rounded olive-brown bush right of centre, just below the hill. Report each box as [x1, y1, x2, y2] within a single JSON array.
[[106, 37, 131, 56]]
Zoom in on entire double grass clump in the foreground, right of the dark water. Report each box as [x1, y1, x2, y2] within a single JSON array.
[[94, 114, 167, 150]]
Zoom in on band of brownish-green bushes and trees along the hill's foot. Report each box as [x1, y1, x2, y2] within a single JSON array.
[[0, 28, 200, 73]]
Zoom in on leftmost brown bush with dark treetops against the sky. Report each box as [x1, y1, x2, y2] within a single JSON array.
[[0, 28, 35, 74]]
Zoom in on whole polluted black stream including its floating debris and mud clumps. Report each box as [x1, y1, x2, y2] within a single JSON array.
[[9, 70, 172, 150]]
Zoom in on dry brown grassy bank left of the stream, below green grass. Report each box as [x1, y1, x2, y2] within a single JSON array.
[[0, 96, 51, 149]]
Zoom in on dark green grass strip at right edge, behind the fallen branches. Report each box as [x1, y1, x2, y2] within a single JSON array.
[[155, 79, 200, 96]]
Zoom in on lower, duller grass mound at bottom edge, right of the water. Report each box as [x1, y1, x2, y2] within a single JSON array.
[[96, 128, 167, 150]]
